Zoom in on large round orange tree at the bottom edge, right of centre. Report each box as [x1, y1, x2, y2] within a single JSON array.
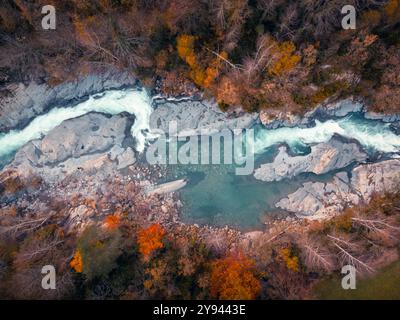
[[210, 253, 261, 300]]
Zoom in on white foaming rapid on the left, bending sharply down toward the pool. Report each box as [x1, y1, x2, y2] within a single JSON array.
[[0, 89, 152, 157]]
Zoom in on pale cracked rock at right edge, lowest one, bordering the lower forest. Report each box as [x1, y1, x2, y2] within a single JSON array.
[[276, 159, 400, 219]]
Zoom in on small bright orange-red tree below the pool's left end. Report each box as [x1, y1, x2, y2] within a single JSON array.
[[138, 223, 165, 259]]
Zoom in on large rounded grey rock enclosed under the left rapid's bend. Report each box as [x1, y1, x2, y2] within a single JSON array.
[[6, 113, 135, 182]]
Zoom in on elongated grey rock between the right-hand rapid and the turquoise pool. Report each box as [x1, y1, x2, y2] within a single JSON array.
[[254, 138, 368, 181]]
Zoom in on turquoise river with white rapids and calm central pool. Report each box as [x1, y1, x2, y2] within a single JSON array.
[[0, 89, 400, 229]]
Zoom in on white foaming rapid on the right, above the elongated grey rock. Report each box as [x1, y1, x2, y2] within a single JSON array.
[[254, 116, 400, 153]]
